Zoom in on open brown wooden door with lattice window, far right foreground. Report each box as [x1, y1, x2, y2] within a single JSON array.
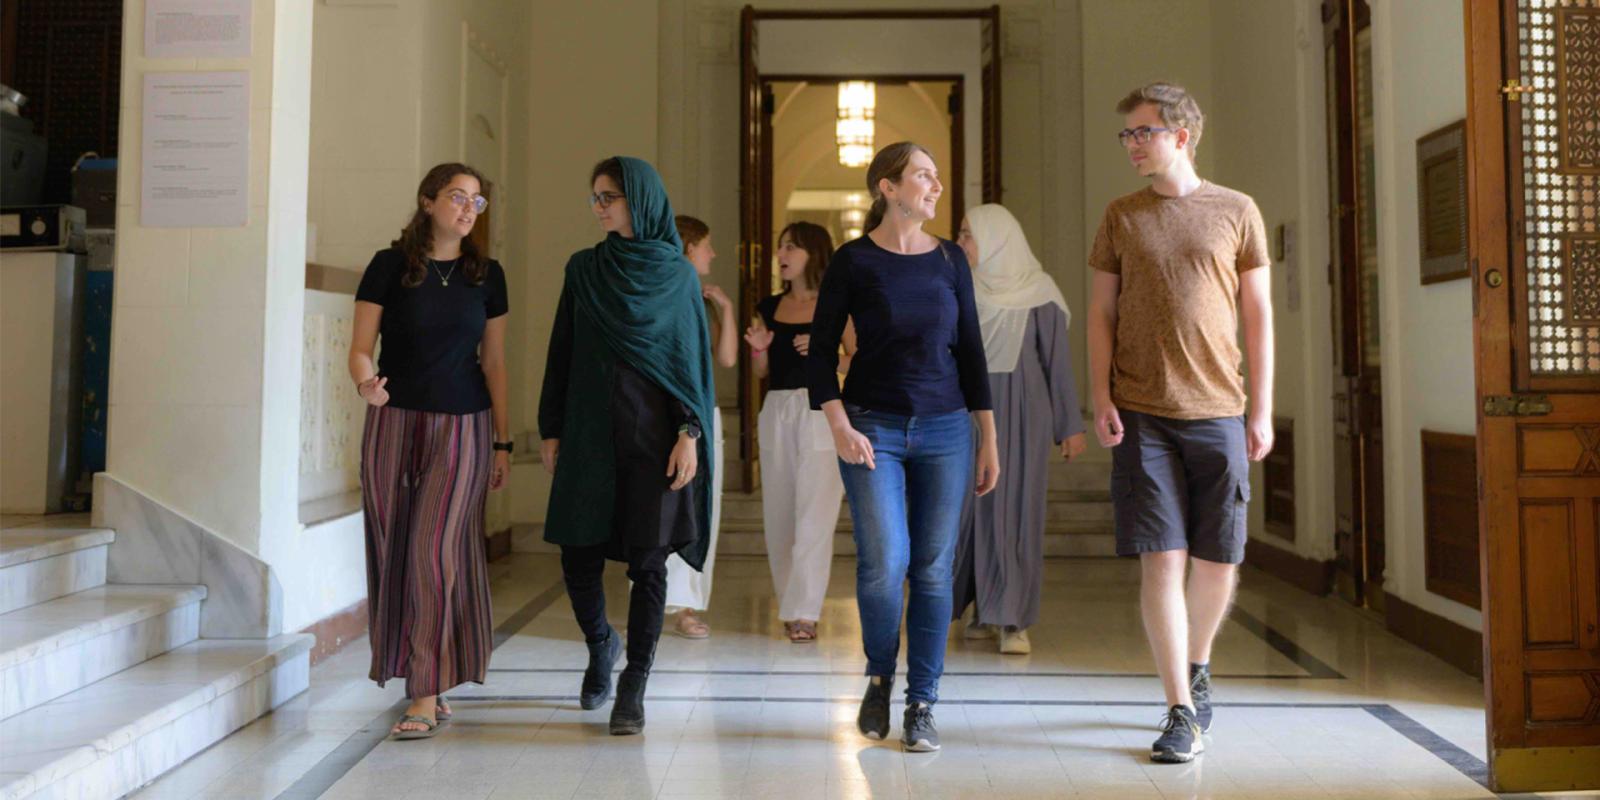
[[1466, 0, 1600, 792]]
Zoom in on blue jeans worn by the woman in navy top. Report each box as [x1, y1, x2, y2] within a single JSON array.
[[838, 403, 973, 704]]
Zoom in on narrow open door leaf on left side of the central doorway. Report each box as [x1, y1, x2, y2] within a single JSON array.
[[723, 6, 773, 491]]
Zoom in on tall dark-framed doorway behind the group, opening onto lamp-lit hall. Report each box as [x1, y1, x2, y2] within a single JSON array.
[[738, 6, 1002, 491]]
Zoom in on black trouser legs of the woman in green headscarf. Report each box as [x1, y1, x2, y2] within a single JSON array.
[[562, 544, 672, 675]]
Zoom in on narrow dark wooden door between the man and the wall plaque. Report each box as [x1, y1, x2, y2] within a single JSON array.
[[1322, 0, 1384, 611]]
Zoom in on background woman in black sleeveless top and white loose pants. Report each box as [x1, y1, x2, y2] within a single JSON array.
[[744, 222, 854, 643]]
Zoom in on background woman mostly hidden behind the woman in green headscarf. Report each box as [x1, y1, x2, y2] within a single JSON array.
[[666, 214, 739, 638]]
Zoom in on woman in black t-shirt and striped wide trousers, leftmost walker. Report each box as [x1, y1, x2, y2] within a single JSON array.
[[350, 163, 510, 739]]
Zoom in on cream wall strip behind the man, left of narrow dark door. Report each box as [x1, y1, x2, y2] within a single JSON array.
[[1200, 0, 1334, 560]]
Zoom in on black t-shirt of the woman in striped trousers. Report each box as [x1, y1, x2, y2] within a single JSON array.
[[355, 248, 507, 414]]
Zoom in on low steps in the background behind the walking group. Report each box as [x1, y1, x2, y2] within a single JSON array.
[[717, 459, 1117, 557]]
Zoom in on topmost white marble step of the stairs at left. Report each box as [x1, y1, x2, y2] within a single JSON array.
[[0, 528, 115, 614]]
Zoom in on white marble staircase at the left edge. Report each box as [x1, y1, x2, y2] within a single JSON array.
[[0, 515, 314, 800]]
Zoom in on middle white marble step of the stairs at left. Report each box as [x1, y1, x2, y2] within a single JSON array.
[[0, 584, 206, 720]]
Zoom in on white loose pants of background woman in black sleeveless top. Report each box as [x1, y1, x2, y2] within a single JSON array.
[[758, 389, 845, 621]]
